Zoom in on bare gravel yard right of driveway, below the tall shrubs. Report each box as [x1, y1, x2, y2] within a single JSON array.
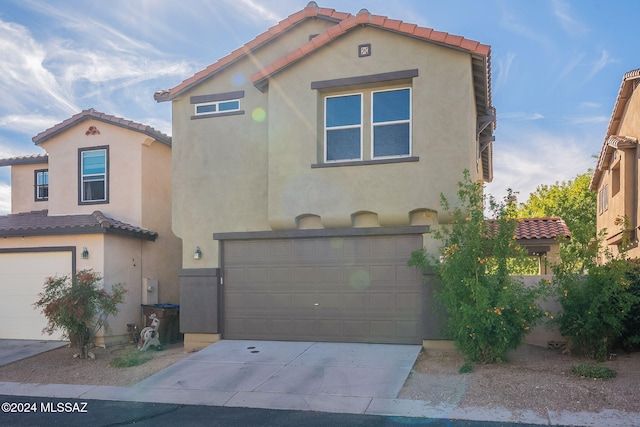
[[398, 345, 640, 415]]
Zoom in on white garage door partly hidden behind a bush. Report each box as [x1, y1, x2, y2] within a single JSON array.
[[0, 251, 71, 340]]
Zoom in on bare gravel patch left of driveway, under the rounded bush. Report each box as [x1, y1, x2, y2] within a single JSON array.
[[0, 343, 189, 387]]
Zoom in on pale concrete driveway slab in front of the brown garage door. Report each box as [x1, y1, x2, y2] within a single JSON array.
[[134, 340, 421, 412]]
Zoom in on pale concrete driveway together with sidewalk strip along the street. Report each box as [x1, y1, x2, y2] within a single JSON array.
[[0, 340, 640, 426]]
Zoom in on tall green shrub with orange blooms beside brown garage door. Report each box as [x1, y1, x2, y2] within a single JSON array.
[[409, 171, 546, 363]]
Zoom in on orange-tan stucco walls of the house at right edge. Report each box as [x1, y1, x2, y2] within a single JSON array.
[[597, 85, 640, 258]]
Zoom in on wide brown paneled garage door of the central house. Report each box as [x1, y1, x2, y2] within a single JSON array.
[[222, 235, 424, 344]]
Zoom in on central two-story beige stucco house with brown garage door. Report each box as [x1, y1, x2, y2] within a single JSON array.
[[155, 1, 495, 348]]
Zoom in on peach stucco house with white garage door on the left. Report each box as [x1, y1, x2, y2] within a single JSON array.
[[0, 109, 182, 344]]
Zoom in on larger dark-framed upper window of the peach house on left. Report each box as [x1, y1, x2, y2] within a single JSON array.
[[80, 148, 107, 202]]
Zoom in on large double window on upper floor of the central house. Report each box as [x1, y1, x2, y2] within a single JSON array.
[[325, 88, 411, 162]]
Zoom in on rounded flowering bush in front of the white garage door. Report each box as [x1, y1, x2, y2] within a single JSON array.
[[34, 270, 126, 356]]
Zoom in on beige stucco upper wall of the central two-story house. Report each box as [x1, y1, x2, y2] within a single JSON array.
[[172, 20, 479, 268]]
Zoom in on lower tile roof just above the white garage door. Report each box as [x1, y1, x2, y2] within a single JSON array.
[[0, 210, 158, 241]]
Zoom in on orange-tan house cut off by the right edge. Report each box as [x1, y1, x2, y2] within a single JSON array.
[[591, 69, 640, 258]]
